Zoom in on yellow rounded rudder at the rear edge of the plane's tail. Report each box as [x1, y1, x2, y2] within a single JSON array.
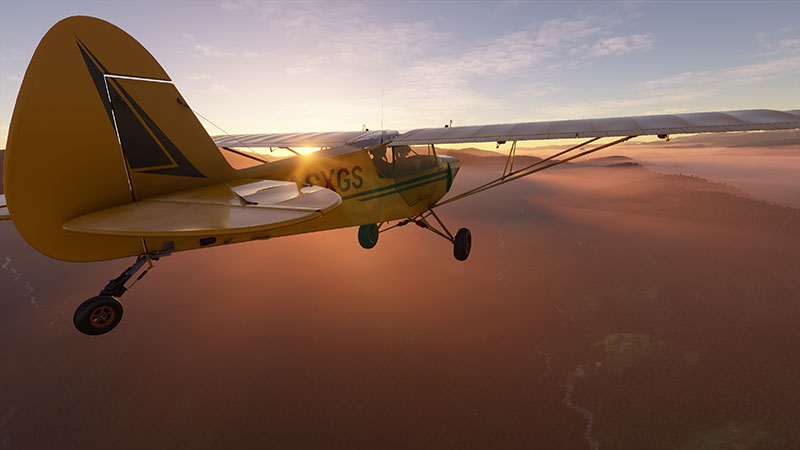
[[4, 17, 148, 261]]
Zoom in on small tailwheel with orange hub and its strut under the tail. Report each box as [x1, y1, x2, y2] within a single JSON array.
[[72, 254, 165, 336]]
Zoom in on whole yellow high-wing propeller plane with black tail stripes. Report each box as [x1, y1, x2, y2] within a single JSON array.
[[0, 17, 800, 335]]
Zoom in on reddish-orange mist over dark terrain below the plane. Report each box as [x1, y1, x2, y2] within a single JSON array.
[[0, 134, 800, 450]]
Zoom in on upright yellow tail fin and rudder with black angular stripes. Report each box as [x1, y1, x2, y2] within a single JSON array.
[[4, 17, 235, 261]]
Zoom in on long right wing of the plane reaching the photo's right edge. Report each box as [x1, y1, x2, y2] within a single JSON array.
[[391, 109, 800, 145]]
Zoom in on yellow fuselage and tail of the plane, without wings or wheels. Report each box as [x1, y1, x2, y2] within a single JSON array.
[[4, 17, 454, 261]]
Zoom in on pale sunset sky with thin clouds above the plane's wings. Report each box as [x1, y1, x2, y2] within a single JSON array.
[[0, 0, 800, 149]]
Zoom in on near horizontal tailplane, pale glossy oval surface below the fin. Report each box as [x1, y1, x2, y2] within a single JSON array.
[[63, 180, 342, 238]]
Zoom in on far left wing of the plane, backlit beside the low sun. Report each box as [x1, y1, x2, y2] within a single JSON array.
[[211, 130, 399, 148]]
